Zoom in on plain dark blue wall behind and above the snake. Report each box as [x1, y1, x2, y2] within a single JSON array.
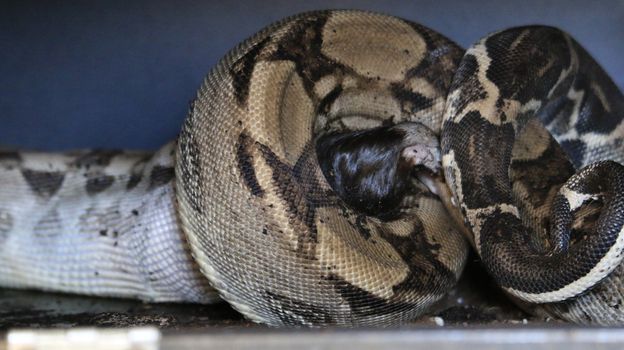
[[0, 0, 624, 150]]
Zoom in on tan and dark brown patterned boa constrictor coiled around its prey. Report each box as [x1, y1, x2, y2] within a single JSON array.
[[0, 11, 624, 326]]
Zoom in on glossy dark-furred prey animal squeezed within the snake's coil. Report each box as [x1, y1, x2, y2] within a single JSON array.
[[316, 122, 441, 218]]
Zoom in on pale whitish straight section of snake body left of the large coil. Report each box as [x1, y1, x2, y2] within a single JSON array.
[[0, 143, 218, 303]]
